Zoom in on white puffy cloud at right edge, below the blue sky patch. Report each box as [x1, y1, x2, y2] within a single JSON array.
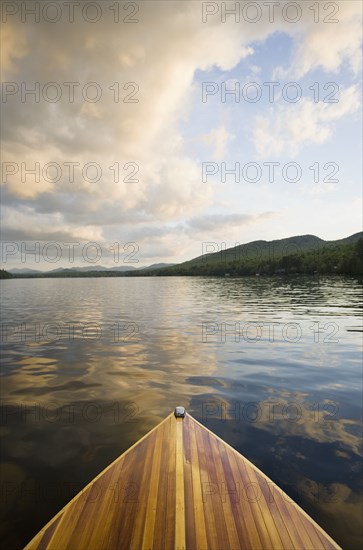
[[252, 86, 360, 158]]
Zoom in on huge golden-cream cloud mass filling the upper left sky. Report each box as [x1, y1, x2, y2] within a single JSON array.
[[3, 2, 256, 224]]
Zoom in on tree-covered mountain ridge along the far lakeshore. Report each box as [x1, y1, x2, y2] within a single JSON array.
[[9, 232, 363, 277]]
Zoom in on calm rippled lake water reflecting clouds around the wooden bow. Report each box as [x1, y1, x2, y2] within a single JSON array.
[[1, 277, 362, 549]]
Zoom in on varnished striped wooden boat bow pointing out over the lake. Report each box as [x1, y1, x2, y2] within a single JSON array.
[[26, 407, 340, 550]]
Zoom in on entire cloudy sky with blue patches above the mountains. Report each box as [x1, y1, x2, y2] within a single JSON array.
[[1, 0, 362, 270]]
